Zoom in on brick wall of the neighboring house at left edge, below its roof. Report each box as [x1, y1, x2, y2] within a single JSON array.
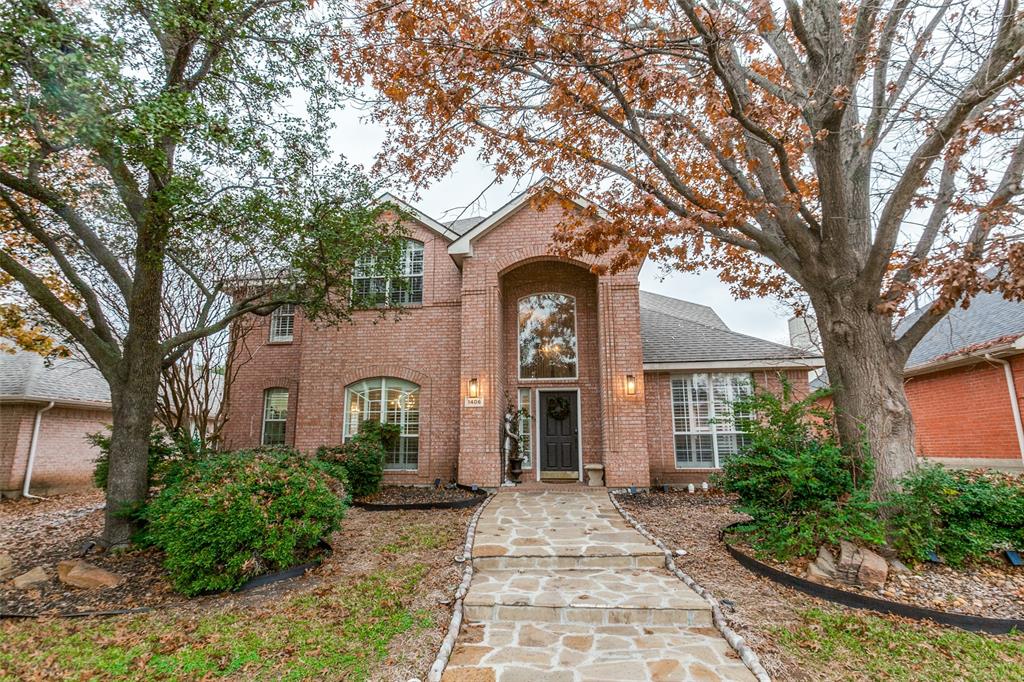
[[0, 402, 111, 497]]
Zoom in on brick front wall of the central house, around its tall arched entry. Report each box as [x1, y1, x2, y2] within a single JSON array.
[[225, 193, 806, 487]]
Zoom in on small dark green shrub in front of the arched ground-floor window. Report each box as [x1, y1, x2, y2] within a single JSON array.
[[316, 421, 393, 498]]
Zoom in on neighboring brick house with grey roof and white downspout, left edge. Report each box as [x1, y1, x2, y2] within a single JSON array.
[[0, 350, 112, 497]]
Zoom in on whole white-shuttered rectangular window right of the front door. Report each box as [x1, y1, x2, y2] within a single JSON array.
[[672, 372, 753, 469]]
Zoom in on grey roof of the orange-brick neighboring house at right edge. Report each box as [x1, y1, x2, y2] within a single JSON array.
[[896, 293, 1024, 369]]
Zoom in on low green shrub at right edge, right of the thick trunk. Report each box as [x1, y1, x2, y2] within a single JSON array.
[[887, 465, 1024, 566]]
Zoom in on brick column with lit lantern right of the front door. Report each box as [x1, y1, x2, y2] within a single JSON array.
[[597, 273, 650, 487]]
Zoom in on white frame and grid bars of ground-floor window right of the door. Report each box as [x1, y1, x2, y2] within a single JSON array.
[[669, 372, 754, 470]]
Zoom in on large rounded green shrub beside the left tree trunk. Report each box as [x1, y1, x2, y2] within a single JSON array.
[[142, 449, 345, 596]]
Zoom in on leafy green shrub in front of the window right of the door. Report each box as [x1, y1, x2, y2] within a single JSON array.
[[715, 384, 885, 560]]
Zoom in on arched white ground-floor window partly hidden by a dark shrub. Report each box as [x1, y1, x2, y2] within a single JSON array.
[[342, 377, 420, 471]]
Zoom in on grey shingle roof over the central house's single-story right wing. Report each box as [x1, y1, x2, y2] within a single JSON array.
[[640, 292, 821, 369]]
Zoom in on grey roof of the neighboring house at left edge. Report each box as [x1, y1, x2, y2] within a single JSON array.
[[0, 343, 111, 407]]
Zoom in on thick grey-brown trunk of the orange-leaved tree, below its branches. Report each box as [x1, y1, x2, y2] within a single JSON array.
[[814, 297, 916, 500]]
